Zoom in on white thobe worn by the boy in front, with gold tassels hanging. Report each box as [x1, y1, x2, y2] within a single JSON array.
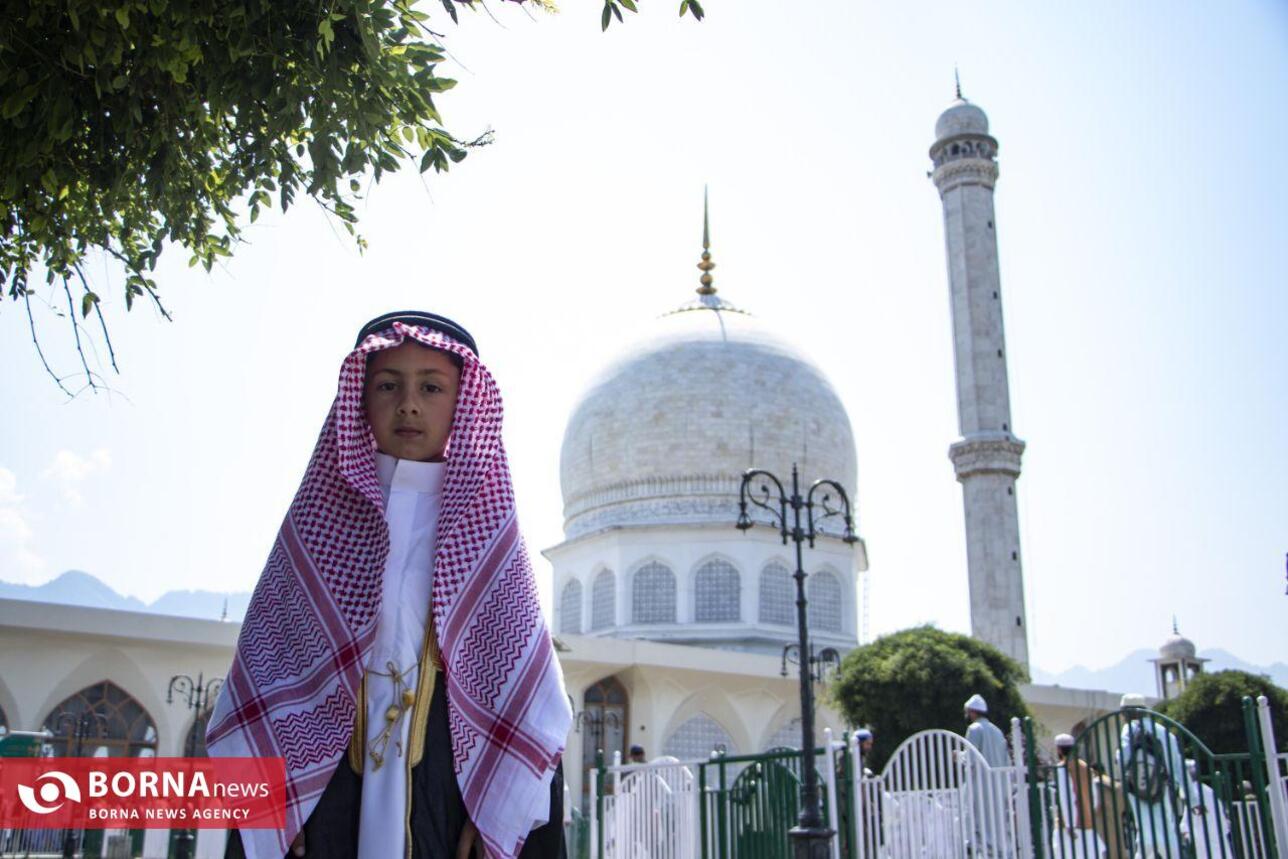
[[358, 453, 447, 859]]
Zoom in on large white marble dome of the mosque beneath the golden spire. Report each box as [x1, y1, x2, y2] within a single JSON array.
[[560, 294, 858, 540]]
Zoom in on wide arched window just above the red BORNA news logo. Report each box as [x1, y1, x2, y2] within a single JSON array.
[[45, 680, 157, 757]]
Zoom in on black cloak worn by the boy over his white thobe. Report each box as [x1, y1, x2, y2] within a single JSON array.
[[224, 672, 567, 859]]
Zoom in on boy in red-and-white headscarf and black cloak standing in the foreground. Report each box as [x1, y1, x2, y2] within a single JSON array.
[[207, 312, 572, 859]]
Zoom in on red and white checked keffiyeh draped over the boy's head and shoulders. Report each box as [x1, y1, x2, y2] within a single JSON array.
[[206, 322, 572, 859]]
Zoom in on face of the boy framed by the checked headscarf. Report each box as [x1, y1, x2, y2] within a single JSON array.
[[362, 340, 461, 462]]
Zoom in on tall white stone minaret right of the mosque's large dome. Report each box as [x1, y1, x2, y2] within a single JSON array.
[[930, 82, 1029, 667]]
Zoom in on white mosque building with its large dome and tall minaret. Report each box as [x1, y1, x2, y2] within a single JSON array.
[[0, 93, 1138, 844]]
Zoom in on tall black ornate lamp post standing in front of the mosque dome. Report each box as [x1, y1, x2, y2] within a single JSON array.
[[737, 464, 859, 859]]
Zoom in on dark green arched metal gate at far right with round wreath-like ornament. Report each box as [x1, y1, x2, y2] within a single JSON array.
[[1024, 699, 1278, 859]]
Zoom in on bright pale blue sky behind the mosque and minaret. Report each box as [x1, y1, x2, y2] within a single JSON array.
[[0, 0, 1288, 670]]
